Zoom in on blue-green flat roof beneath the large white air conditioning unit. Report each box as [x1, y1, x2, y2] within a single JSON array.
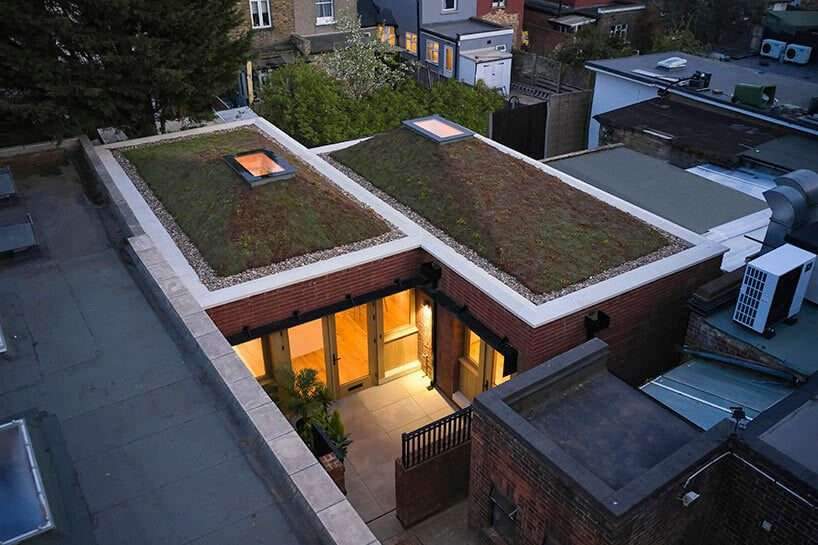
[[704, 300, 818, 377]]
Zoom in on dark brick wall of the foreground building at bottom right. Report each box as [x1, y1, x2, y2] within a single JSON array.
[[469, 411, 719, 545]]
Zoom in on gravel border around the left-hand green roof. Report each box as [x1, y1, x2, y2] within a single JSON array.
[[112, 125, 406, 291]]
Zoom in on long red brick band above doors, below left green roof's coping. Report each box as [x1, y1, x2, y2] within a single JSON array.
[[207, 250, 428, 336]]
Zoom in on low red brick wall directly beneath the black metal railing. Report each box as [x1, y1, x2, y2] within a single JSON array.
[[395, 442, 471, 528]]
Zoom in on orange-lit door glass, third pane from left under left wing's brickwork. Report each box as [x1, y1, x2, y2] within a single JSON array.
[[335, 305, 369, 384]]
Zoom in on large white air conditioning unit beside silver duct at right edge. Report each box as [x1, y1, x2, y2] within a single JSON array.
[[733, 244, 815, 338]]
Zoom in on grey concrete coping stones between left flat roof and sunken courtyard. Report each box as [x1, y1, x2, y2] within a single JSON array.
[[122, 235, 379, 545]]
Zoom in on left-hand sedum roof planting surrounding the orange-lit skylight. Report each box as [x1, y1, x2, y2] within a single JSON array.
[[119, 127, 391, 277]]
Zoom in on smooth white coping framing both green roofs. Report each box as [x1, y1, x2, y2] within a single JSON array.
[[96, 117, 727, 327]]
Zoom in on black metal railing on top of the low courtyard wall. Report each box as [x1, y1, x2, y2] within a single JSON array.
[[401, 407, 471, 469]]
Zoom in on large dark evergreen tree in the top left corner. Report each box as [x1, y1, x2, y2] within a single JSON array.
[[0, 0, 249, 137]]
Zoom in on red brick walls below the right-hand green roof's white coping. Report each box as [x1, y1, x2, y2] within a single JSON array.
[[435, 254, 721, 395]]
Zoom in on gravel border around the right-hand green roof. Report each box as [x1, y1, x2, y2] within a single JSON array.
[[320, 153, 691, 305]]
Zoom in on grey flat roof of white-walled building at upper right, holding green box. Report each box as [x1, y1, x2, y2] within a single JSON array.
[[586, 51, 818, 128]]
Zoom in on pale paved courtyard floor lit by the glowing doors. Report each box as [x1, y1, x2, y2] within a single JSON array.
[[335, 371, 455, 524]]
